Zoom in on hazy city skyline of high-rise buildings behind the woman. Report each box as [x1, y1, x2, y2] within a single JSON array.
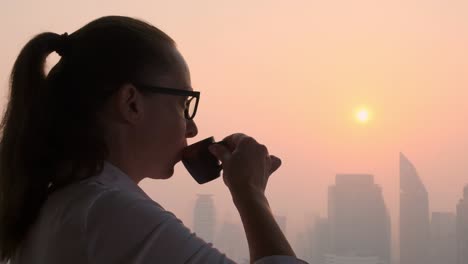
[[199, 156, 468, 264]]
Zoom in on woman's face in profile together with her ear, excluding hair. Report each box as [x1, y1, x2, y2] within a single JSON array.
[[99, 44, 197, 182]]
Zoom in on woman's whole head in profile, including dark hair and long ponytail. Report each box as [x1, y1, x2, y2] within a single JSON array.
[[0, 16, 197, 261]]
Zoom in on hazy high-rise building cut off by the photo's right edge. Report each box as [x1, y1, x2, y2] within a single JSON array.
[[457, 185, 468, 264]]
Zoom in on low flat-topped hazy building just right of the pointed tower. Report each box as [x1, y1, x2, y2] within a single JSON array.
[[429, 212, 457, 264]]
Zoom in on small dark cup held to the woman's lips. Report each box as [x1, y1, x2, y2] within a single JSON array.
[[182, 137, 226, 184]]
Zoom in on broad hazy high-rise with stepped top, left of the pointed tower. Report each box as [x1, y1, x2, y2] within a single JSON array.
[[328, 174, 391, 264]]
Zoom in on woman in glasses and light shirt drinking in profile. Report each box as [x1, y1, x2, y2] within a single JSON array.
[[0, 16, 302, 264]]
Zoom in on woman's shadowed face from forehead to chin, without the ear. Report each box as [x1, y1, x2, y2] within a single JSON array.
[[139, 48, 198, 179]]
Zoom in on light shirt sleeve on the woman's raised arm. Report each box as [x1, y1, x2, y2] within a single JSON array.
[[83, 190, 304, 264]]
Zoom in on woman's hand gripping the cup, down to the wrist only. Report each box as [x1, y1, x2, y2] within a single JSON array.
[[210, 133, 281, 197]]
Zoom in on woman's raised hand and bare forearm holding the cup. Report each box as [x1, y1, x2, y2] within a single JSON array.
[[210, 134, 295, 263]]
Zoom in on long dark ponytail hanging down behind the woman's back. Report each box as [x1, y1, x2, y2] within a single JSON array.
[[0, 33, 65, 261]]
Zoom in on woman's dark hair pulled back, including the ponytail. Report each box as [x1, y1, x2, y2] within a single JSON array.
[[0, 16, 175, 261]]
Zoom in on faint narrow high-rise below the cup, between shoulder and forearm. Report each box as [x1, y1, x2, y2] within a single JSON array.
[[193, 194, 216, 242]]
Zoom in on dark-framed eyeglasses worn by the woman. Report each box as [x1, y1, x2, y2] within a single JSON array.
[[134, 84, 200, 120]]
